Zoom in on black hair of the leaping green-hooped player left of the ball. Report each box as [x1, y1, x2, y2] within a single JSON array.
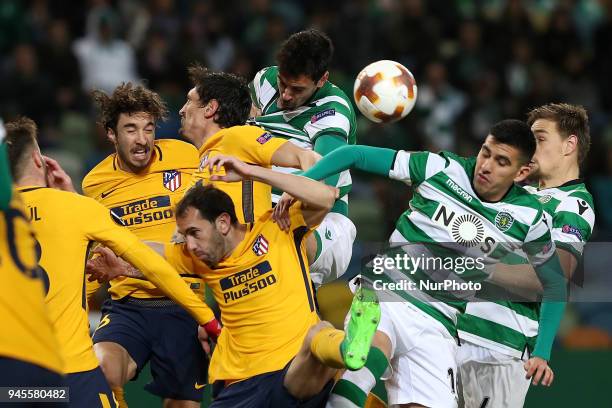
[[276, 29, 334, 82]]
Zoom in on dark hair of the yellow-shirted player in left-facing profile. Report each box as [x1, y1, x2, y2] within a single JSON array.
[[188, 64, 251, 128]]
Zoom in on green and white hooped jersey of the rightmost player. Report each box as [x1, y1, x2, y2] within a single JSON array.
[[457, 180, 595, 358]]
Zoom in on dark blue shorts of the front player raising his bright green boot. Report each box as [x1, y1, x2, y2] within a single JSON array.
[[209, 364, 334, 408]]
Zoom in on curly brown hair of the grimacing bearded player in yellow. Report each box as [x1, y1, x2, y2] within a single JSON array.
[[92, 82, 168, 132]]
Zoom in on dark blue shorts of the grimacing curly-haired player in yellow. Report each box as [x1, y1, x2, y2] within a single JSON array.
[[93, 297, 208, 401]]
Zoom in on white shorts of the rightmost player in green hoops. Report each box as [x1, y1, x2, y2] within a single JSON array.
[[457, 342, 530, 407]]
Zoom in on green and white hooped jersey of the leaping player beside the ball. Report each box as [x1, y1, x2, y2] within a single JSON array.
[[249, 66, 356, 212]]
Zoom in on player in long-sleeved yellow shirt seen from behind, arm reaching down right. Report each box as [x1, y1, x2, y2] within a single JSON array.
[[7, 118, 219, 408]]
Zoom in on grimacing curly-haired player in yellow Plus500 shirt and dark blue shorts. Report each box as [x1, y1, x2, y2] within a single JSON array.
[[83, 84, 206, 407]]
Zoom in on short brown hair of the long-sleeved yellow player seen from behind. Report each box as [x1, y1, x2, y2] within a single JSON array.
[[5, 116, 38, 180]]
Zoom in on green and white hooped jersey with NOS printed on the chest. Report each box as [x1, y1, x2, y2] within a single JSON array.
[[380, 151, 554, 335]]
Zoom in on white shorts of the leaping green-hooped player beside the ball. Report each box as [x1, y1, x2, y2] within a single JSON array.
[[306, 213, 357, 286]]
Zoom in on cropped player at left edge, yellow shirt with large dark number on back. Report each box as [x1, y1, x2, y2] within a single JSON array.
[[0, 125, 64, 387]]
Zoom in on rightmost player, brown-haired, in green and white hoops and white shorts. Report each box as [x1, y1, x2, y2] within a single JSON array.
[[457, 104, 595, 407]]
